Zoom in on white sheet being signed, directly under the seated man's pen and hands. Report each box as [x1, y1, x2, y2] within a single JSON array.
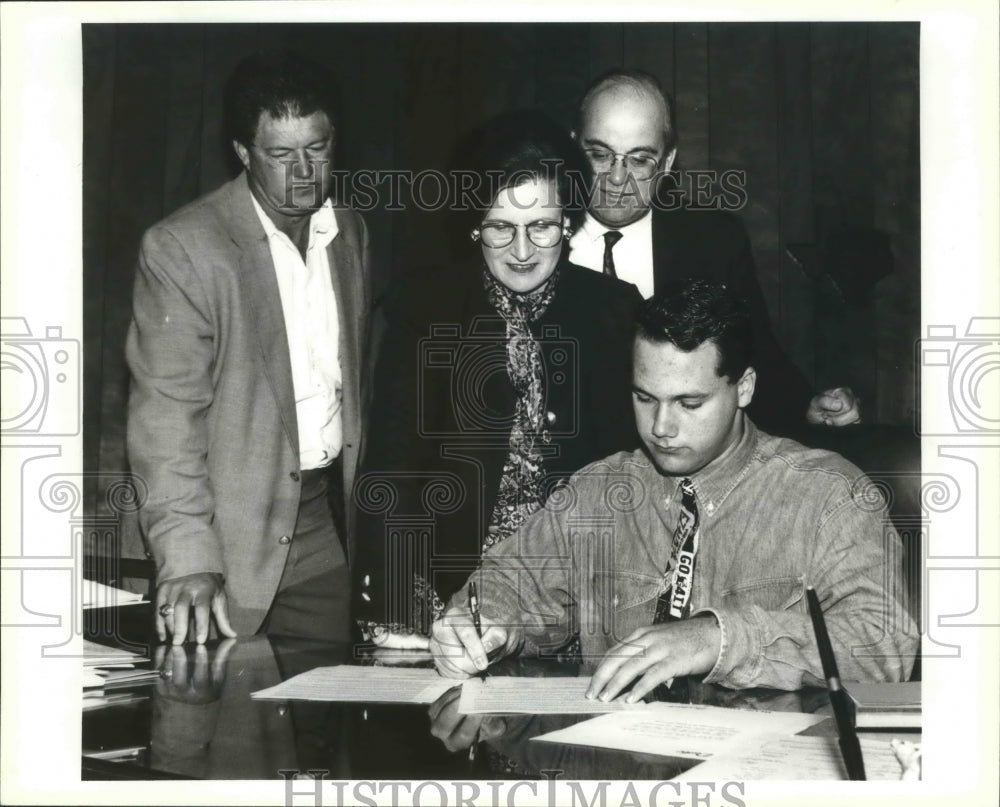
[[458, 675, 647, 715]]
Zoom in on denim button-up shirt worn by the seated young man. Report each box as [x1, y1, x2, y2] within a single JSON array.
[[464, 419, 918, 690]]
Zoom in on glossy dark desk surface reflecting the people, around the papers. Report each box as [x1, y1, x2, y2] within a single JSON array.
[[82, 606, 908, 780]]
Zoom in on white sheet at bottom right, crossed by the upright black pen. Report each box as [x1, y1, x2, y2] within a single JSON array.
[[676, 736, 901, 781]]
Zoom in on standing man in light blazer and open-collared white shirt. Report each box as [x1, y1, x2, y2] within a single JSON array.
[[126, 52, 371, 644]]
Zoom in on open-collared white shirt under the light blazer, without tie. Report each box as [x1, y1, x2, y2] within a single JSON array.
[[253, 199, 343, 471]]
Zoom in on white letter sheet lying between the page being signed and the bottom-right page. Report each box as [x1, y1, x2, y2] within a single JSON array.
[[534, 703, 824, 759]]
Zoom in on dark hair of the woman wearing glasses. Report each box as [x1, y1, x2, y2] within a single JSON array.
[[456, 109, 593, 229]]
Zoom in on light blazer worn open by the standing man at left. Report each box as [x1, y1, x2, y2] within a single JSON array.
[[125, 174, 372, 634]]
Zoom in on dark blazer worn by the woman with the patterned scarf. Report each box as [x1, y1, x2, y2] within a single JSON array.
[[354, 261, 642, 628]]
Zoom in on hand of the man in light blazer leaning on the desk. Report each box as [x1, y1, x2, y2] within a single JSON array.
[[156, 572, 236, 645]]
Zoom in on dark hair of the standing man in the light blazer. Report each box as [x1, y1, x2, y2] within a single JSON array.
[[223, 50, 339, 147]]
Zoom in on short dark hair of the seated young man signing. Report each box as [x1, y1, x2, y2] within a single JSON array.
[[635, 280, 754, 384]]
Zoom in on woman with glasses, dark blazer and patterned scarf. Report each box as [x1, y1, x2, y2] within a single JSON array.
[[352, 112, 641, 646]]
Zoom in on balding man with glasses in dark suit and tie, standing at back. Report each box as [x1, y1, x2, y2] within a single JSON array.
[[570, 70, 861, 433]]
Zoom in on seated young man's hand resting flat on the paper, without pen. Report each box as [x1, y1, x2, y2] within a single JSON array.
[[587, 615, 722, 703]]
